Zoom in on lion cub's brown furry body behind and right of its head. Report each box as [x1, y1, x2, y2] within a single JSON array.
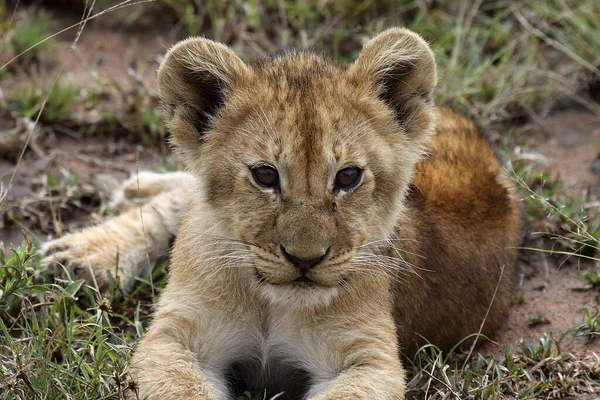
[[395, 109, 520, 350]]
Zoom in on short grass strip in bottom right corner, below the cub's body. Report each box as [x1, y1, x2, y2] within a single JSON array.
[[408, 334, 599, 399]]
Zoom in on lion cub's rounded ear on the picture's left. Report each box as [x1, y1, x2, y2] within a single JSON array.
[[157, 38, 250, 148]]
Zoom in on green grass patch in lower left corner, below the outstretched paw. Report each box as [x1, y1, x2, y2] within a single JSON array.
[[0, 240, 164, 399]]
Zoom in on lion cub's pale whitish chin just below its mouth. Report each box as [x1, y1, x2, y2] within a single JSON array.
[[261, 283, 339, 309]]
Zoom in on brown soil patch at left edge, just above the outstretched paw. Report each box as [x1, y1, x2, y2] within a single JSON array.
[[0, 136, 162, 246]]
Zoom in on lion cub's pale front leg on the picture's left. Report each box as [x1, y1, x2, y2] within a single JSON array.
[[129, 293, 231, 400]]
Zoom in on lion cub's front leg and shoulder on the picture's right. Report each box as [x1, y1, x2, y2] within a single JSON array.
[[273, 277, 405, 400]]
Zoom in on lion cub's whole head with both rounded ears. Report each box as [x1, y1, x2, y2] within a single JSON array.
[[158, 29, 436, 306]]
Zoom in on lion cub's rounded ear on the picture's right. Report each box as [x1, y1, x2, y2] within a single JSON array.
[[349, 28, 437, 136]]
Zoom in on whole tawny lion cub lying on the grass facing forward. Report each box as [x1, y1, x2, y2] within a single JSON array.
[[44, 29, 519, 400]]
